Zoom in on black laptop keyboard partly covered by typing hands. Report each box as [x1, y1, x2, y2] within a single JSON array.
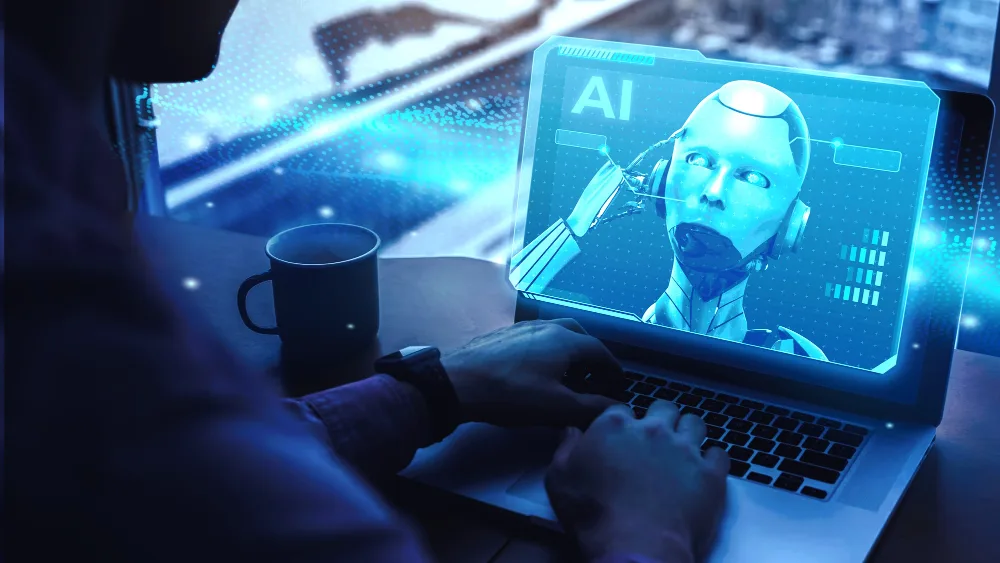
[[567, 372, 868, 499]]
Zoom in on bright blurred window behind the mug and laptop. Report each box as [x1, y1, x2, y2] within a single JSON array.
[[145, 0, 998, 261]]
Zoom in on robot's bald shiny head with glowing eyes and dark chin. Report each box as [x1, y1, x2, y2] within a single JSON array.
[[663, 80, 809, 271]]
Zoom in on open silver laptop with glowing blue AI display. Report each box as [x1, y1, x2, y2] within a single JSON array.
[[403, 37, 993, 563]]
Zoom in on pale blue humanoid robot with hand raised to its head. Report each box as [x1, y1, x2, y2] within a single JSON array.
[[510, 80, 827, 360]]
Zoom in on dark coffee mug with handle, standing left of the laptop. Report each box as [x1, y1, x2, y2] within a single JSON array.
[[237, 223, 381, 360]]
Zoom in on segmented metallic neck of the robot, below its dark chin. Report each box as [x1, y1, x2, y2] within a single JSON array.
[[657, 260, 749, 342]]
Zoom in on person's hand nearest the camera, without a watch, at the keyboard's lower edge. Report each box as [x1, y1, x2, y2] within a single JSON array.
[[545, 401, 729, 562]]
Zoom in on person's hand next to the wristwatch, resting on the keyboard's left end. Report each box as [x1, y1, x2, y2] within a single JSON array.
[[441, 319, 622, 427]]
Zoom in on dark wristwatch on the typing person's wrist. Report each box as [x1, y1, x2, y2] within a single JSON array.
[[375, 346, 462, 442]]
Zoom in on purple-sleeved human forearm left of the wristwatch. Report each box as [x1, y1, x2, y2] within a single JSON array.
[[287, 375, 431, 480]]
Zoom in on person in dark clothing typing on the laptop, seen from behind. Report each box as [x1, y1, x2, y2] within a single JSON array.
[[0, 0, 728, 563]]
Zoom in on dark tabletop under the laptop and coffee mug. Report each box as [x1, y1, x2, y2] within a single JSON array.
[[136, 218, 1000, 563]]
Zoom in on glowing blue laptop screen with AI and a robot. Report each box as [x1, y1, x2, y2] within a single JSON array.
[[510, 39, 988, 403]]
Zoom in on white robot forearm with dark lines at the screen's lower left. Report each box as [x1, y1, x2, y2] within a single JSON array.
[[510, 219, 580, 293]]
